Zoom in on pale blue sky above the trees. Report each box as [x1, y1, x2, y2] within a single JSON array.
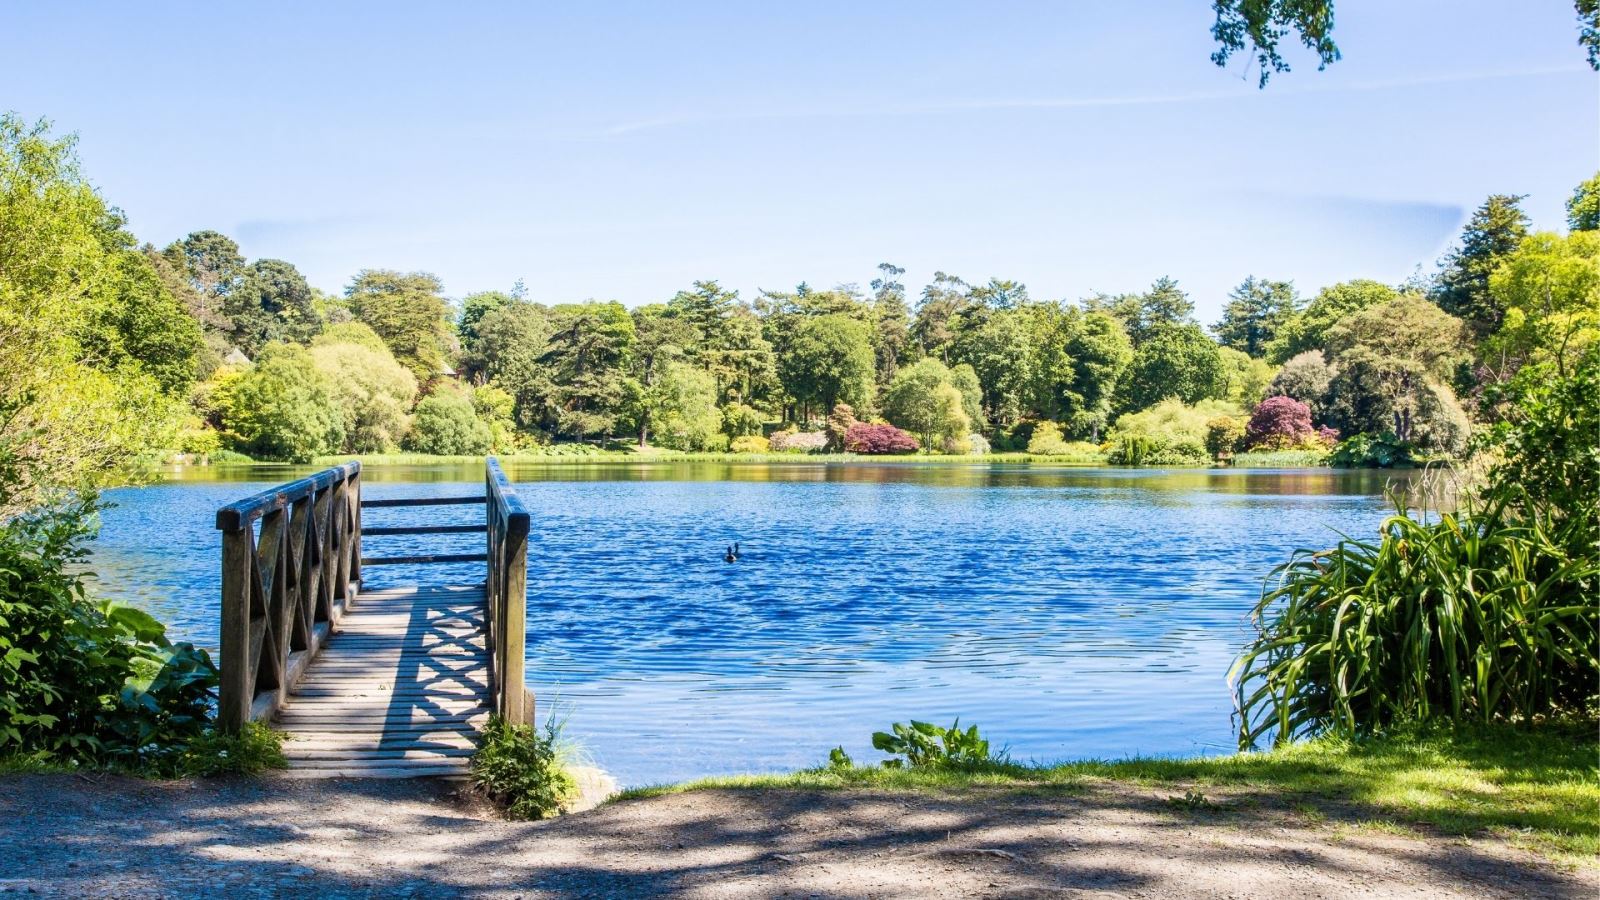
[[0, 0, 1600, 320]]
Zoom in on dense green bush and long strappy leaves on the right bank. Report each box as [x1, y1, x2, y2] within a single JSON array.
[[1230, 352, 1600, 746]]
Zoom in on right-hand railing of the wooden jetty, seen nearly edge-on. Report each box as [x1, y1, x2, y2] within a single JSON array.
[[483, 456, 533, 725]]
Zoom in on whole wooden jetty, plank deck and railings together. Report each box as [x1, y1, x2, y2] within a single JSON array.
[[216, 458, 533, 777]]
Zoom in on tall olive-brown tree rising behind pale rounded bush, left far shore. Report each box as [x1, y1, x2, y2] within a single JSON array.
[[344, 269, 453, 377]]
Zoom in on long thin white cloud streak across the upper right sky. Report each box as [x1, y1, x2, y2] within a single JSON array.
[[581, 66, 1589, 139]]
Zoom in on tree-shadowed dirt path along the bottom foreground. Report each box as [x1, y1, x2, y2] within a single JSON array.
[[0, 775, 1600, 900]]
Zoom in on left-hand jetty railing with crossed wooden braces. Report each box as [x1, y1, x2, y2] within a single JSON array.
[[216, 461, 362, 732]]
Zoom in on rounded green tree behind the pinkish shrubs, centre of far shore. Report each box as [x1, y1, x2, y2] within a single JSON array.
[[778, 312, 877, 420]]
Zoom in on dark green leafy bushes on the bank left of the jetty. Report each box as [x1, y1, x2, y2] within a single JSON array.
[[0, 500, 218, 767]]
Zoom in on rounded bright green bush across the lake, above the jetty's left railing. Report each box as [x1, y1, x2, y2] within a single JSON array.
[[214, 344, 346, 463]]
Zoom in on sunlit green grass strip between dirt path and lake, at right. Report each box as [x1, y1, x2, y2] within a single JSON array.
[[614, 724, 1600, 866]]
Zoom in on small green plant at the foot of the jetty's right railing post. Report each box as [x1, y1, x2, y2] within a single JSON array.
[[472, 716, 578, 818]]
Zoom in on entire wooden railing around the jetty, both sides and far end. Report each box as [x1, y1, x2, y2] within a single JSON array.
[[216, 458, 533, 730]]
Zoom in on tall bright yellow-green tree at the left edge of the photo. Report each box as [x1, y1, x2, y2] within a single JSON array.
[[0, 114, 182, 509]]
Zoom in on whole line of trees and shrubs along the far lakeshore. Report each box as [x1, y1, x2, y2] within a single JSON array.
[[0, 108, 1600, 469]]
